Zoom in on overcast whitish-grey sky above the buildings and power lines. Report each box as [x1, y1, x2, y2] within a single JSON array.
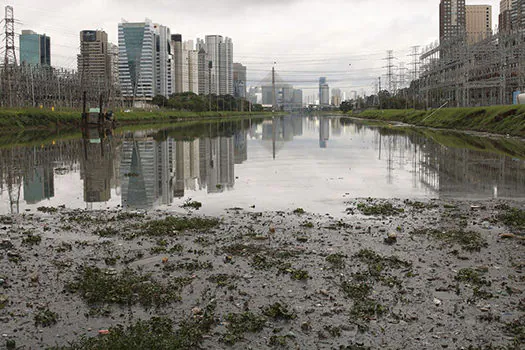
[[4, 0, 499, 98]]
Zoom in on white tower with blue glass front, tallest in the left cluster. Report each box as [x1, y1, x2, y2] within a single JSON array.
[[118, 20, 156, 100]]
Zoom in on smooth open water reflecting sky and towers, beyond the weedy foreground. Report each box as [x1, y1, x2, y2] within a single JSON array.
[[0, 116, 525, 213]]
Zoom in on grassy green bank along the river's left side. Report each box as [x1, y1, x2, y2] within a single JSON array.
[[0, 108, 270, 132]]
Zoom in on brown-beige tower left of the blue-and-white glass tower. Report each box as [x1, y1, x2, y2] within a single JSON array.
[[77, 30, 113, 88]]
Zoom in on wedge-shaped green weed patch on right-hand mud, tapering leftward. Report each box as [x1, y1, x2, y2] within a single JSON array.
[[411, 229, 488, 252]]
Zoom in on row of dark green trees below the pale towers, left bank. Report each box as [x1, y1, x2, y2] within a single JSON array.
[[152, 92, 263, 112]]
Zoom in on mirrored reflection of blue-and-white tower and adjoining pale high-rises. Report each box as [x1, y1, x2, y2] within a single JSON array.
[[120, 120, 248, 208]]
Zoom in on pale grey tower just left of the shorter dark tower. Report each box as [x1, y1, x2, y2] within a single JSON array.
[[197, 35, 233, 95]]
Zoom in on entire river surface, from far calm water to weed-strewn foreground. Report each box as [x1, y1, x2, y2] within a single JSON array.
[[0, 116, 525, 350]]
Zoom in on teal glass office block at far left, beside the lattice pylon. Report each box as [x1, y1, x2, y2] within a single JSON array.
[[20, 30, 51, 66]]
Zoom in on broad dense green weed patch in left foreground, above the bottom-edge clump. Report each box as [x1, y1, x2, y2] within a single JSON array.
[[67, 267, 185, 307]]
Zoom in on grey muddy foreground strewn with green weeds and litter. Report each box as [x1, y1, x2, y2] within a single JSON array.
[[0, 199, 525, 350]]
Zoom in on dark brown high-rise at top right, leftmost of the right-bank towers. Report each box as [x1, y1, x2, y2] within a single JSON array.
[[439, 0, 467, 44]]
